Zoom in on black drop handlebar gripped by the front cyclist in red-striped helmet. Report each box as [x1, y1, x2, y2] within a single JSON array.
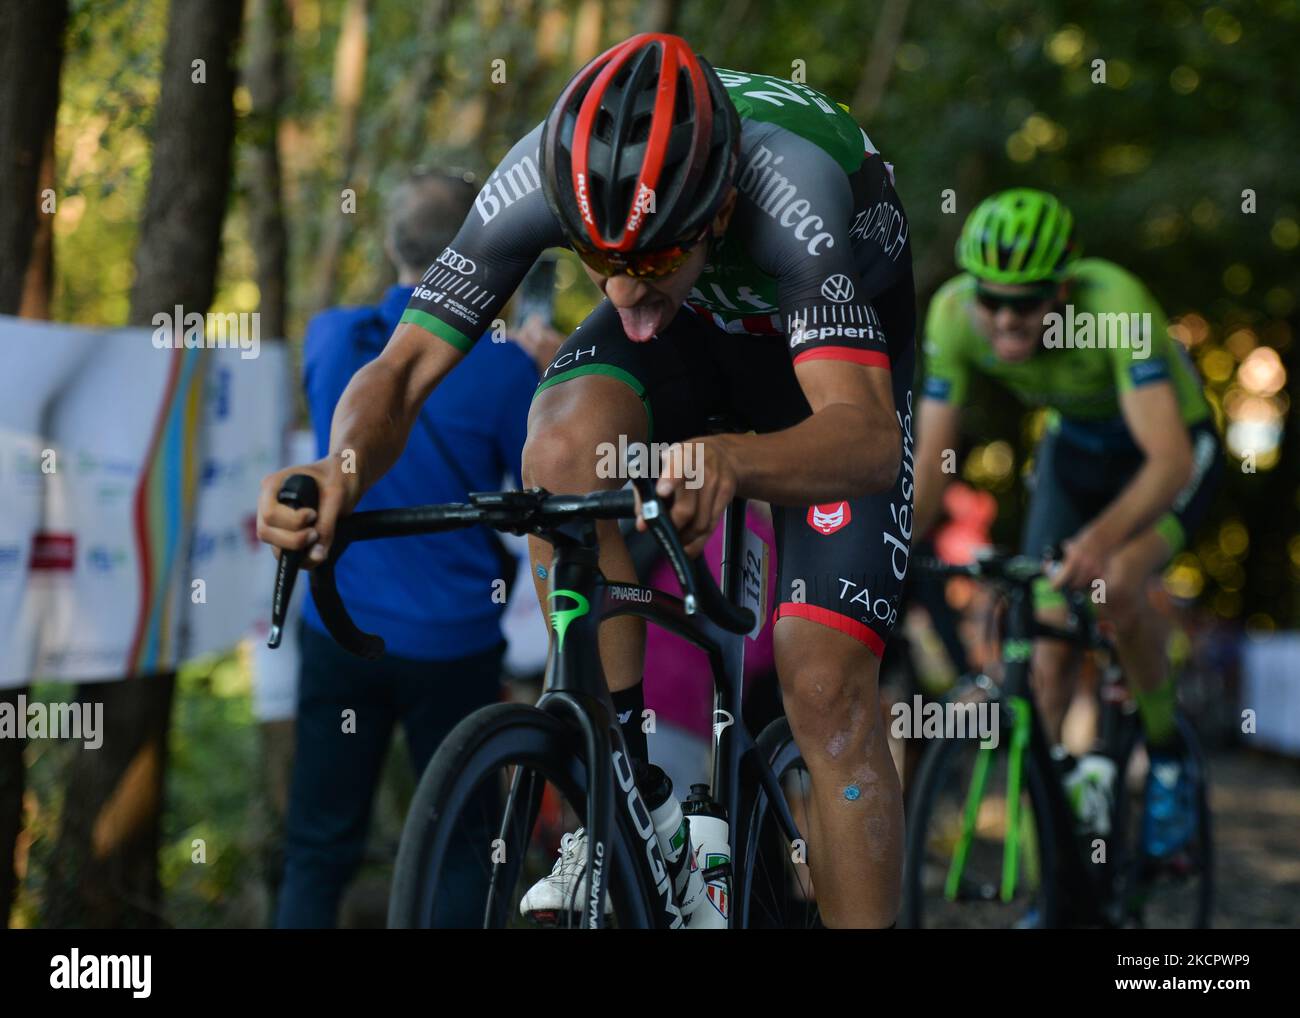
[[267, 473, 754, 660]]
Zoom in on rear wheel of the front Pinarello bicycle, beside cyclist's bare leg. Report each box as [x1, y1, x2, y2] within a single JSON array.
[[733, 718, 820, 930]]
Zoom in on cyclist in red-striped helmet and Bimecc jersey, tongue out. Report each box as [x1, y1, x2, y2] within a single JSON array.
[[259, 34, 915, 927]]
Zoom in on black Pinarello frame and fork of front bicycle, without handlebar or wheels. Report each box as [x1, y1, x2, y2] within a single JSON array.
[[520, 499, 800, 928]]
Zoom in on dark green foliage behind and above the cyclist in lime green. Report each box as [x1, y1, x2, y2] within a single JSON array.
[[684, 0, 1300, 628]]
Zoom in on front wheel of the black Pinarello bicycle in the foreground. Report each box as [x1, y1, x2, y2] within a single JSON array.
[[389, 703, 651, 930]]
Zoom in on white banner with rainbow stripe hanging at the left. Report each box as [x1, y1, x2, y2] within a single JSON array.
[[0, 316, 291, 688]]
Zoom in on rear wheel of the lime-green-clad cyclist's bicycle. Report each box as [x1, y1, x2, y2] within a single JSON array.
[[1115, 714, 1214, 930]]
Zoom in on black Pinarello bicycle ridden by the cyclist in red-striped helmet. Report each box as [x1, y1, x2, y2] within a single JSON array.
[[269, 475, 819, 928]]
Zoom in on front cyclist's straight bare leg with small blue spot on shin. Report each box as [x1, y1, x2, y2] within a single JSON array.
[[775, 616, 904, 927]]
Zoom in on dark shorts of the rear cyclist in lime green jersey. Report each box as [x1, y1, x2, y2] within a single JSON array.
[[1021, 421, 1223, 607]]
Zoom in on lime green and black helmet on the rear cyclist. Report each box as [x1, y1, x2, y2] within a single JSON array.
[[957, 187, 1079, 283]]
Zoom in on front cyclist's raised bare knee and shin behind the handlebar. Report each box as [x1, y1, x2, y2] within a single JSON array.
[[523, 374, 647, 692]]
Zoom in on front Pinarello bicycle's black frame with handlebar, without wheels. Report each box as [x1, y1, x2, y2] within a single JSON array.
[[267, 475, 798, 927]]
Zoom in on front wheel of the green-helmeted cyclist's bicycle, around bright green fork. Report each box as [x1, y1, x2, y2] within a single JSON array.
[[898, 725, 1061, 928]]
